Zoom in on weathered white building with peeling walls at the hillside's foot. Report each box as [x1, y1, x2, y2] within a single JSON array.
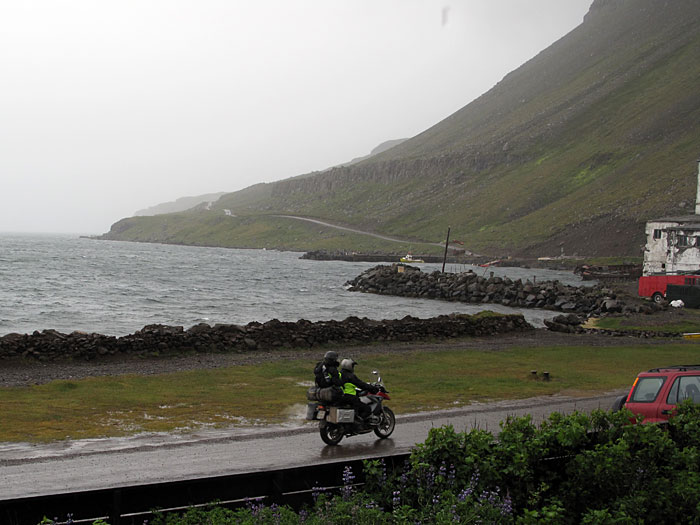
[[642, 161, 700, 275]]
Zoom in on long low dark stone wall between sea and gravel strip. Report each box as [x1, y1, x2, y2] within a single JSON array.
[[0, 314, 533, 361]]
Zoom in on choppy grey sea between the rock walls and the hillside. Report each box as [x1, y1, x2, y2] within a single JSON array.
[[0, 234, 592, 336]]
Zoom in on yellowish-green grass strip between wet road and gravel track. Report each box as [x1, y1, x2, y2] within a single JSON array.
[[0, 343, 698, 442]]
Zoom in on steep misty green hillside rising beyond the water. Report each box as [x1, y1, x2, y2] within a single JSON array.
[[98, 0, 700, 256]]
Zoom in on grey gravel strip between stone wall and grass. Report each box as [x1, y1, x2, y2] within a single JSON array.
[[0, 329, 692, 387]]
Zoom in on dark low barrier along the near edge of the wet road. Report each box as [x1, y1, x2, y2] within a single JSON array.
[[0, 454, 409, 525]]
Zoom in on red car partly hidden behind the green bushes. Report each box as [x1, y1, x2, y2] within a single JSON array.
[[613, 365, 700, 423]]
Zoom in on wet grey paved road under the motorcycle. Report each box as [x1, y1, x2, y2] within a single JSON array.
[[0, 392, 624, 500]]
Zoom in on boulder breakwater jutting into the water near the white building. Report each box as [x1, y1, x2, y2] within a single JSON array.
[[346, 264, 650, 320]]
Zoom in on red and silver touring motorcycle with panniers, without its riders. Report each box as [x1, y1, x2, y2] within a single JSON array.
[[306, 370, 396, 445]]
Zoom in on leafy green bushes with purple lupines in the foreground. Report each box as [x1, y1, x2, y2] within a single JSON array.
[[45, 403, 700, 525]]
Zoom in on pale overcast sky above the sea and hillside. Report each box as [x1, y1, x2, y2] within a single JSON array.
[[0, 0, 592, 234]]
